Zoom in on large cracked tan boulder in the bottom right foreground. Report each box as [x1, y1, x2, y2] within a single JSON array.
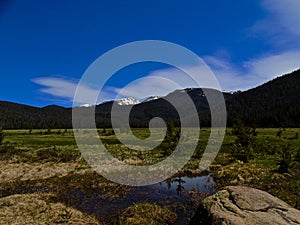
[[198, 186, 300, 225]]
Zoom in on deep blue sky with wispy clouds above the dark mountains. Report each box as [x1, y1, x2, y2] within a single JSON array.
[[0, 0, 300, 106]]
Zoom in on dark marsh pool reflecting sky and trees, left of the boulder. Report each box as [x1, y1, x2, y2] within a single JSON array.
[[52, 175, 215, 225]]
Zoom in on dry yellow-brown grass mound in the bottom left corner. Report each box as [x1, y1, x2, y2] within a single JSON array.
[[0, 194, 100, 225]]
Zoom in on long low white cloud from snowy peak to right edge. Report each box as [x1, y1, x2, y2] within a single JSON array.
[[114, 51, 300, 98]]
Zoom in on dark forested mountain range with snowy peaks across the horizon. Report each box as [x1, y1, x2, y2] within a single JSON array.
[[0, 70, 300, 129]]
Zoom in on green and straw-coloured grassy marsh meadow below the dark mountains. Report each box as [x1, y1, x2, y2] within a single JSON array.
[[0, 128, 300, 224]]
